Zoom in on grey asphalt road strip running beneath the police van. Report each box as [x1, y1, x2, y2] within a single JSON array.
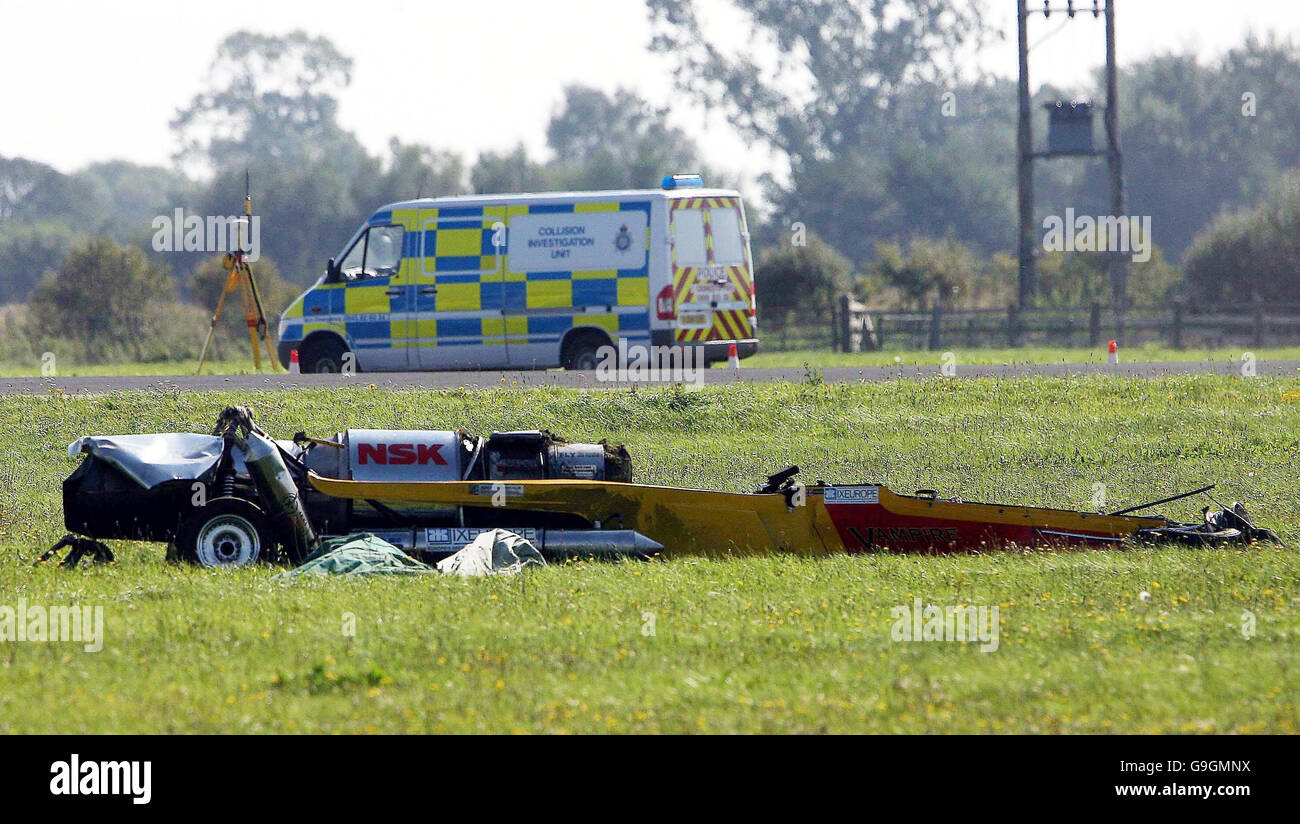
[[0, 360, 1300, 395]]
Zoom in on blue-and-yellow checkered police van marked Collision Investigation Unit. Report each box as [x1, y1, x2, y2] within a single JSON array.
[[278, 175, 758, 372]]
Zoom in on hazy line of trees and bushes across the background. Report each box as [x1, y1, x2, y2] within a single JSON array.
[[0, 0, 1300, 359]]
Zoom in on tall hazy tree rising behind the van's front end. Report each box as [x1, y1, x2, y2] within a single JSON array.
[[172, 31, 465, 283]]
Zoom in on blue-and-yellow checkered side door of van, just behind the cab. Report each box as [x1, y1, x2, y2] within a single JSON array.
[[412, 207, 507, 369]]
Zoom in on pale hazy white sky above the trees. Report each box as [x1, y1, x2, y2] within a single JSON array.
[[0, 0, 1300, 178]]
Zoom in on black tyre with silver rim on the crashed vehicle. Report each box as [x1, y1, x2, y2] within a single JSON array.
[[176, 498, 276, 568]]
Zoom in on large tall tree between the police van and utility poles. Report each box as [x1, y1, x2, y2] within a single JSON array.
[[647, 0, 993, 264]]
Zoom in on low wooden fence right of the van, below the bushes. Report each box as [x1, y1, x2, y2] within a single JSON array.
[[758, 296, 1300, 352]]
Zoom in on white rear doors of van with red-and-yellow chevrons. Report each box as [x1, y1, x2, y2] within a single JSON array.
[[671, 198, 754, 343]]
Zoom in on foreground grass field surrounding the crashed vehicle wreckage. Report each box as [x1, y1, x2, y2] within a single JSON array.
[[0, 377, 1300, 733]]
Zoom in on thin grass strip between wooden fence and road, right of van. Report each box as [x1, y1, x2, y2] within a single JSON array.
[[743, 342, 1300, 367]]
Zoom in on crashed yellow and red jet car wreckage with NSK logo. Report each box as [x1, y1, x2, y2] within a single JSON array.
[[47, 407, 1279, 567]]
